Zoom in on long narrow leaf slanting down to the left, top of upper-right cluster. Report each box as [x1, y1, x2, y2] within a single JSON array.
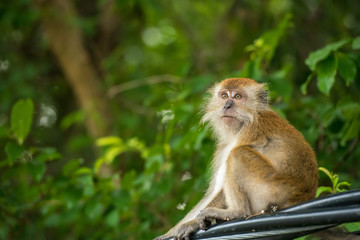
[[305, 39, 349, 71]]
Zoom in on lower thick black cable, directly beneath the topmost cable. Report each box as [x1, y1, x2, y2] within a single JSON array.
[[194, 205, 360, 239]]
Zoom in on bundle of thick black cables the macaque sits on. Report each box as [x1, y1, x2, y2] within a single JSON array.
[[181, 190, 360, 240]]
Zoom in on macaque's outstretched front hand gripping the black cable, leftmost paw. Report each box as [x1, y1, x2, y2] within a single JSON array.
[[154, 220, 200, 240]]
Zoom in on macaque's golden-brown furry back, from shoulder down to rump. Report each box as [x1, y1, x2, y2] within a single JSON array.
[[259, 110, 318, 203]]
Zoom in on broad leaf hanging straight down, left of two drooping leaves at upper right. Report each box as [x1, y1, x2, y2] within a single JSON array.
[[316, 54, 337, 95]]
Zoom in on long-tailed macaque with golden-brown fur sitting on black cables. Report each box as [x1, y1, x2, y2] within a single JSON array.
[[156, 78, 318, 240]]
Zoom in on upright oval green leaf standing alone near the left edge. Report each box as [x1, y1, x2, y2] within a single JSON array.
[[11, 98, 34, 145]]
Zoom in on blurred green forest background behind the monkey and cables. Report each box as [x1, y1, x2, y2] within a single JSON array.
[[0, 0, 360, 239]]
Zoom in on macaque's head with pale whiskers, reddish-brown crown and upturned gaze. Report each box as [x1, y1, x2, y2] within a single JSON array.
[[202, 78, 268, 138]]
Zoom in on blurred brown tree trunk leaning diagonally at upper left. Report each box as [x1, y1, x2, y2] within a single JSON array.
[[36, 0, 111, 138]]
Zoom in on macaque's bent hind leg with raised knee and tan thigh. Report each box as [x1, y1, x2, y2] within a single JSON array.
[[229, 146, 306, 214]]
